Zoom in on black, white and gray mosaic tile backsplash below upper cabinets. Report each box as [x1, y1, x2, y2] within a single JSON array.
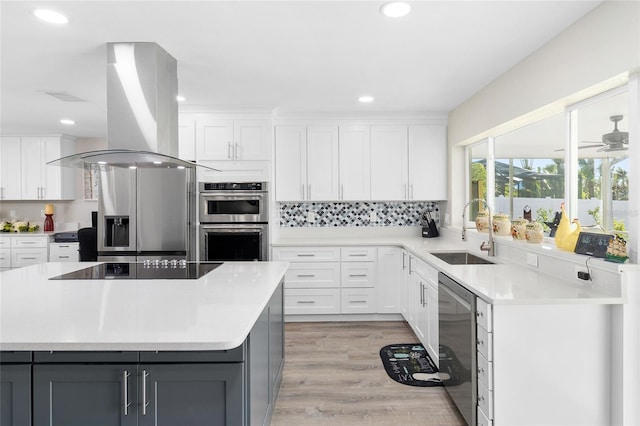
[[280, 201, 440, 228]]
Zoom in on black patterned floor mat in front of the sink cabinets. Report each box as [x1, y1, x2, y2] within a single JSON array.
[[380, 343, 442, 386]]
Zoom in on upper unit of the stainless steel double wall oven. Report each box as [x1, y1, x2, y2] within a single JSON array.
[[199, 182, 269, 223]]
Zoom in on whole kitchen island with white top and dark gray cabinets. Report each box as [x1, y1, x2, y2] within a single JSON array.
[[0, 262, 287, 425]]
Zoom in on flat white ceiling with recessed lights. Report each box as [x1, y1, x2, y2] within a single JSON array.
[[0, 0, 601, 137]]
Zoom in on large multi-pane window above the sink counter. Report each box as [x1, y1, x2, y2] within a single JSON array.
[[467, 87, 629, 240]]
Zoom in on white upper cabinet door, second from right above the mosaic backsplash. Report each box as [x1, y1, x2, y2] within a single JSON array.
[[371, 126, 408, 200]]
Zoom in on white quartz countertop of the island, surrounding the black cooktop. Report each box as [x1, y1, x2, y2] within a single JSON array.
[[0, 262, 287, 351]]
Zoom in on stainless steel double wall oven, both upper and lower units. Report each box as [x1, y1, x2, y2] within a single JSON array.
[[199, 182, 269, 262]]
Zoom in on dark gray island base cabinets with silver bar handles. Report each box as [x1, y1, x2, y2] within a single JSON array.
[[0, 283, 284, 426]]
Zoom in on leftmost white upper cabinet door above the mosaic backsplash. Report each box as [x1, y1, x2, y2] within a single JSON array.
[[275, 126, 307, 201]]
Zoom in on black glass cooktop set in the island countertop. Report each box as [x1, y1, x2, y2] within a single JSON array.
[[49, 261, 222, 280]]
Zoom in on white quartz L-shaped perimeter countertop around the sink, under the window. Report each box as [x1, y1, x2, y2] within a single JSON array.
[[272, 230, 625, 305]]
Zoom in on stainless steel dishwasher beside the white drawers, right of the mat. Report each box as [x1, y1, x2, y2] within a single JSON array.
[[438, 272, 478, 426]]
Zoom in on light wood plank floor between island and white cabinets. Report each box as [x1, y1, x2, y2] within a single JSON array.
[[271, 321, 465, 426]]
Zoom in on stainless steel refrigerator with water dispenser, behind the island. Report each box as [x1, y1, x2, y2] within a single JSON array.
[[97, 164, 196, 261]]
